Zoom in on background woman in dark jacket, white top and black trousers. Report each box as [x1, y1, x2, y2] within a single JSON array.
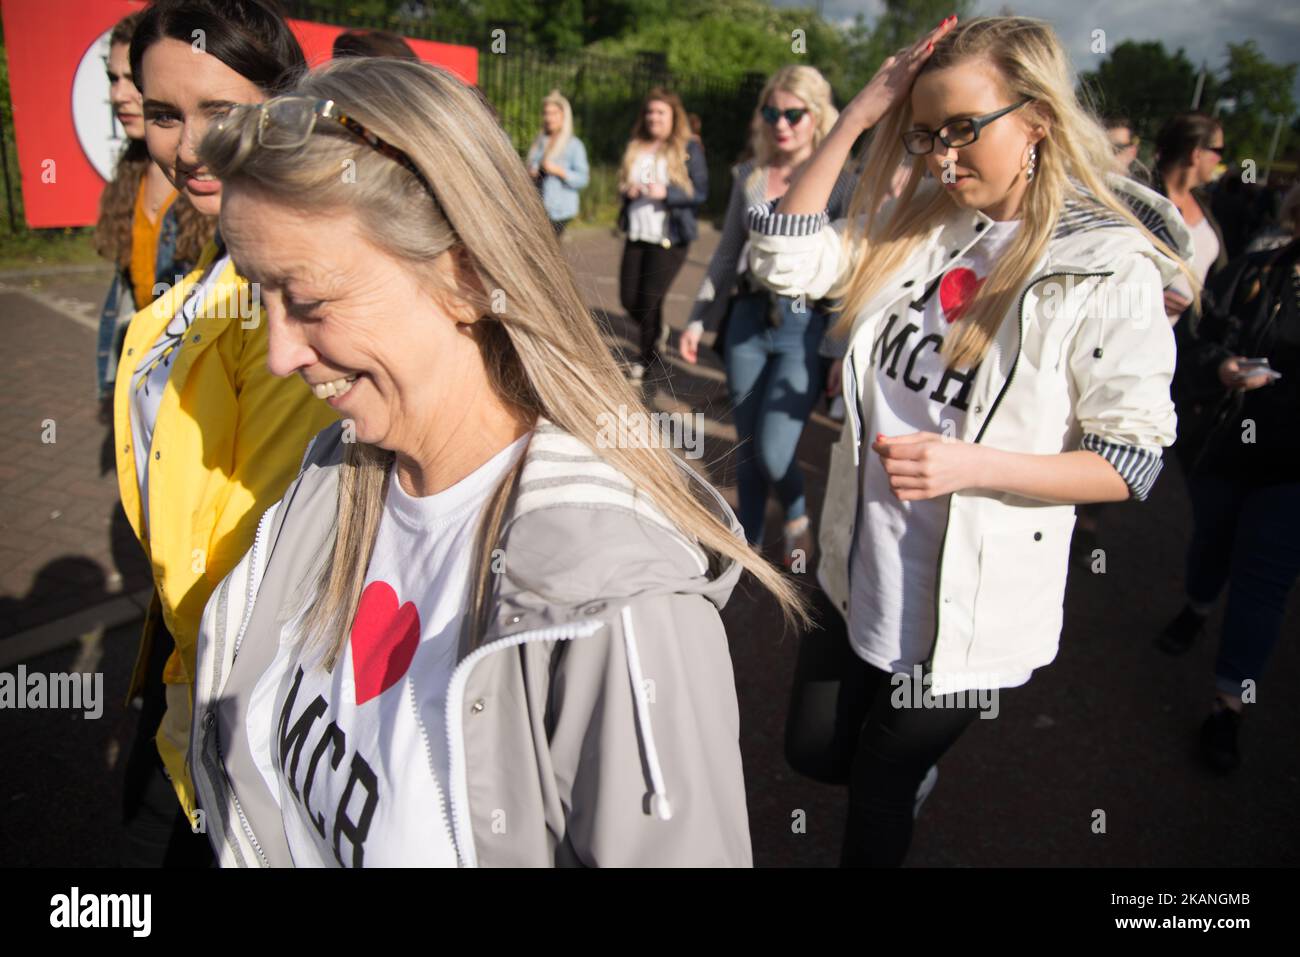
[[619, 87, 709, 384]]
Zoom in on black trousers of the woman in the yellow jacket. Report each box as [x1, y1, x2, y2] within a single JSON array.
[[121, 624, 215, 867]]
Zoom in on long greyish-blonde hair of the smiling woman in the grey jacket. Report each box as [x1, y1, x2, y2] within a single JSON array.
[[200, 59, 806, 667]]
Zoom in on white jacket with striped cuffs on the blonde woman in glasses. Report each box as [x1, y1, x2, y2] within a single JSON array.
[[749, 178, 1191, 693]]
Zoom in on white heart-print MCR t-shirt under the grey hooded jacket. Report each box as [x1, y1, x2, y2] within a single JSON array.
[[247, 436, 529, 867]]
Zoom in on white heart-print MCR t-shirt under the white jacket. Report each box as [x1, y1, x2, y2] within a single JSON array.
[[849, 220, 1030, 693]]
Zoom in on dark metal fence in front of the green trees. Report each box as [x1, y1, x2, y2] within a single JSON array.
[[0, 0, 764, 233]]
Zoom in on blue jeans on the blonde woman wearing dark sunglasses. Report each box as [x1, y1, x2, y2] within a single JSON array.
[[724, 296, 827, 545]]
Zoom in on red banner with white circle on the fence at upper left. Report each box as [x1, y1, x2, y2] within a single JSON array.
[[0, 0, 478, 228]]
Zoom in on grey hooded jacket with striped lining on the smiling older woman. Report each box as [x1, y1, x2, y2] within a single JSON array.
[[190, 421, 753, 866]]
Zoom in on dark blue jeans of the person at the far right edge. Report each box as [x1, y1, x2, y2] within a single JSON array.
[[1187, 475, 1300, 697]]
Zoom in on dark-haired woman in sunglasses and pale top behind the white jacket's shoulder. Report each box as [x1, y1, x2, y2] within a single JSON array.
[[1152, 113, 1227, 325]]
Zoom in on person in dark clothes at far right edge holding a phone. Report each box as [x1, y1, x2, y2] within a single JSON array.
[[1157, 227, 1300, 774]]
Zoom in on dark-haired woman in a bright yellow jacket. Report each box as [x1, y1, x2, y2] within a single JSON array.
[[113, 0, 335, 866]]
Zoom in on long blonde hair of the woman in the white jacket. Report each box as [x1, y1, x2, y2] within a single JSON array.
[[833, 17, 1200, 368]]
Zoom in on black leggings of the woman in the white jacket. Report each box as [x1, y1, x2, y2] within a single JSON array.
[[785, 589, 980, 867]]
